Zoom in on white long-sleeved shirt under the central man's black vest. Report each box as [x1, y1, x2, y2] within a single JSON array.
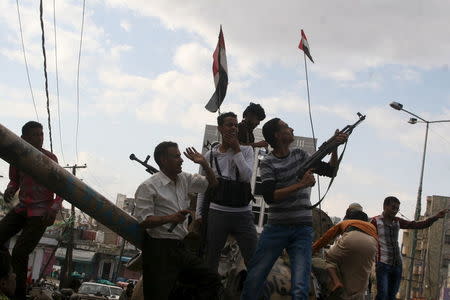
[[196, 145, 255, 218]]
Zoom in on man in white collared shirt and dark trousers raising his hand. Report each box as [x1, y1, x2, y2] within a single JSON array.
[[134, 142, 221, 300]]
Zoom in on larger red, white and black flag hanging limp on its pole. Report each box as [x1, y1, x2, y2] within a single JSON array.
[[205, 26, 228, 112]]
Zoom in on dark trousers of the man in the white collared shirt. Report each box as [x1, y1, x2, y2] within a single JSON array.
[[142, 234, 222, 300]]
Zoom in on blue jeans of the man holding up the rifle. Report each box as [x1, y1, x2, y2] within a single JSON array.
[[241, 224, 313, 300]]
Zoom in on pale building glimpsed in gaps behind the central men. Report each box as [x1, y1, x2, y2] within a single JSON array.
[[202, 125, 315, 232]]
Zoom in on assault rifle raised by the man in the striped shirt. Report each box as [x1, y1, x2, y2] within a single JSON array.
[[297, 112, 366, 179]]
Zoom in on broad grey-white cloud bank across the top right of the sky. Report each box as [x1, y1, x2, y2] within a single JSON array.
[[107, 0, 450, 81]]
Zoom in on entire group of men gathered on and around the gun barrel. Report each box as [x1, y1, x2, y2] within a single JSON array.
[[0, 103, 446, 299]]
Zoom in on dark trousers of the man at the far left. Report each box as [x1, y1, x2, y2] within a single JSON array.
[[0, 209, 47, 300]]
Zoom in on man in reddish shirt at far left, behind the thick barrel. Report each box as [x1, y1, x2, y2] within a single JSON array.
[[0, 121, 62, 299]]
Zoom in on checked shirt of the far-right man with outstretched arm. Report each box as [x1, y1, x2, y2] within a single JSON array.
[[370, 215, 437, 266]]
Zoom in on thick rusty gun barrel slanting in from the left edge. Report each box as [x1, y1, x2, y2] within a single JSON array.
[[0, 124, 143, 248]]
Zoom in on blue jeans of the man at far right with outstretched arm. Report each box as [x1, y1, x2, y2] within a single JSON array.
[[375, 262, 402, 300]]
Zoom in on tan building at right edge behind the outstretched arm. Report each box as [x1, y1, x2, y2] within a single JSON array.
[[399, 196, 450, 299]]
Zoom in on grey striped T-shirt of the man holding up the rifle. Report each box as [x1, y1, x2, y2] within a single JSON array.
[[260, 149, 312, 226]]
